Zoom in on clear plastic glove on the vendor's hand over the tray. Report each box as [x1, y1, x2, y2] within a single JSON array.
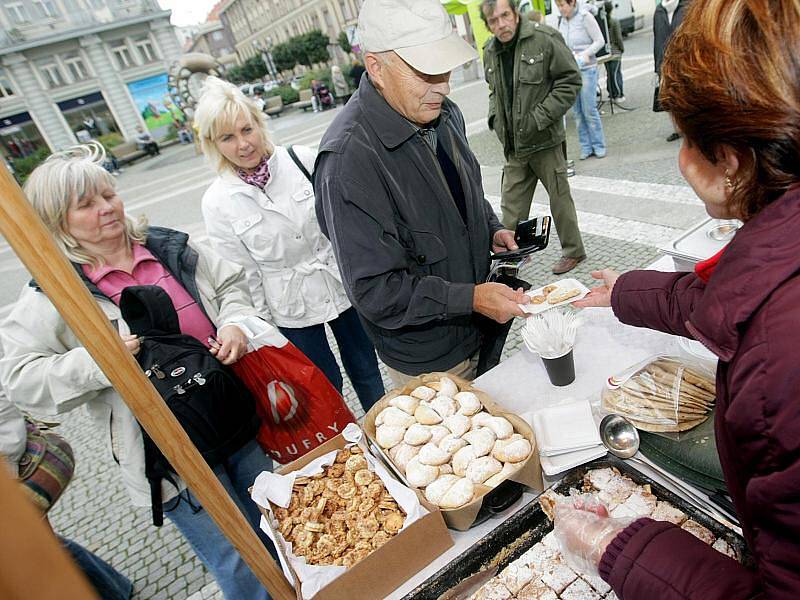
[[554, 494, 635, 575]]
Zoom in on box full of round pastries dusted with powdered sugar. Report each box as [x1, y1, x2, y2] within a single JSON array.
[[364, 373, 542, 530]]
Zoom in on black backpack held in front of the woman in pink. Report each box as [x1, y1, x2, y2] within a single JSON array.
[[119, 285, 260, 527]]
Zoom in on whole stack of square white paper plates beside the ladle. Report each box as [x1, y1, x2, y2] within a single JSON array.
[[533, 400, 606, 475]]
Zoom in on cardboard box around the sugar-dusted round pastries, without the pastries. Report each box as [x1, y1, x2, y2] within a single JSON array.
[[363, 373, 544, 531]]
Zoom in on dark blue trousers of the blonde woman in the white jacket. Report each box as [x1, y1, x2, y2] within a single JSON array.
[[278, 308, 384, 412]]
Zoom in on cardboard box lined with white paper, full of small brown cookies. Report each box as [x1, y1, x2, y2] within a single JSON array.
[[251, 424, 453, 600]]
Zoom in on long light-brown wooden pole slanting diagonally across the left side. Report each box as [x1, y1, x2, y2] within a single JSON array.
[[0, 167, 296, 600]]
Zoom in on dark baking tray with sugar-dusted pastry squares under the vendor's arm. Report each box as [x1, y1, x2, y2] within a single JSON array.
[[404, 457, 751, 600]]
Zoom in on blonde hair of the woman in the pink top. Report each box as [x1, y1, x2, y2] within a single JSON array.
[[23, 142, 147, 265]]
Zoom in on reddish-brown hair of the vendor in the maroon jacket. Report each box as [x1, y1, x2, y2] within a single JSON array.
[[661, 0, 800, 219]]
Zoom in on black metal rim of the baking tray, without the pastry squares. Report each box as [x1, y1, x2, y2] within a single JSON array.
[[403, 455, 751, 600]]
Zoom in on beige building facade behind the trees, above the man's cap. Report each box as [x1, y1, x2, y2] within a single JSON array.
[[219, 0, 363, 66]]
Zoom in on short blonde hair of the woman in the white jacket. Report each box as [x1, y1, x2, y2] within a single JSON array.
[[194, 76, 275, 173]]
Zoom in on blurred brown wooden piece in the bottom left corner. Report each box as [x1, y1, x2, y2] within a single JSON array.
[[0, 468, 97, 600]]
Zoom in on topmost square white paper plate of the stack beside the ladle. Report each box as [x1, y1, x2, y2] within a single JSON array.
[[533, 400, 602, 455]]
